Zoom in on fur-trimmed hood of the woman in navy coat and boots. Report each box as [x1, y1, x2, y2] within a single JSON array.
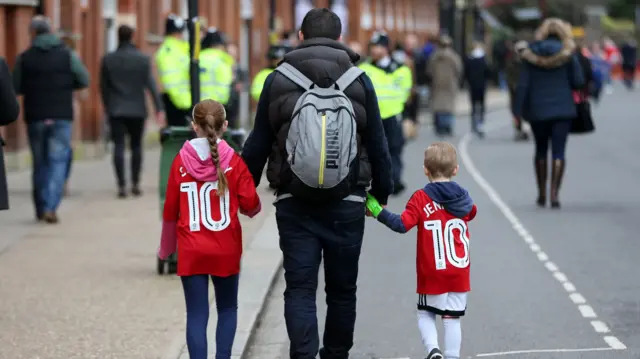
[[521, 18, 576, 68]]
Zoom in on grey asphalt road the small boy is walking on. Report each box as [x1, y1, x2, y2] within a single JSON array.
[[247, 87, 640, 359]]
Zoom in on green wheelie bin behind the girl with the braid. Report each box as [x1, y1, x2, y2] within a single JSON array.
[[157, 126, 195, 275]]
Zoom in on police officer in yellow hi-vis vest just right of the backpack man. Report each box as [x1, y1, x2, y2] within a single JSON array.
[[359, 32, 413, 194]]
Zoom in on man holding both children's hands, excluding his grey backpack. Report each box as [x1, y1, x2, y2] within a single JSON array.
[[242, 8, 393, 359]]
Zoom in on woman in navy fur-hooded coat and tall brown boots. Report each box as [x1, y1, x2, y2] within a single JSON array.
[[514, 18, 584, 208]]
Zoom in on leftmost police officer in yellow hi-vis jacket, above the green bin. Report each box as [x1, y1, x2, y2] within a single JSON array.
[[156, 14, 191, 126]]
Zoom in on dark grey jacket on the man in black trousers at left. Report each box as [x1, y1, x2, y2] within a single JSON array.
[[100, 43, 162, 118]]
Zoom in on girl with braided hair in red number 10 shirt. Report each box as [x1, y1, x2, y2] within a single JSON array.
[[158, 100, 261, 359]]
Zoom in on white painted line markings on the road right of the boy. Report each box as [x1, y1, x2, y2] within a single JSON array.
[[458, 129, 627, 357]]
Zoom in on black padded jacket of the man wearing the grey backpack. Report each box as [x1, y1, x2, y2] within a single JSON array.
[[242, 38, 393, 204]]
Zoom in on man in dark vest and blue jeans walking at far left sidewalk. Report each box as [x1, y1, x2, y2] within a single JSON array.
[[13, 16, 89, 223]]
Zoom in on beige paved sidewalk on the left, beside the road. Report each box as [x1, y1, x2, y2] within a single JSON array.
[[0, 150, 280, 359]]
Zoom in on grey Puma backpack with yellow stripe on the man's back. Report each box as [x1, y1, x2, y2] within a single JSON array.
[[276, 62, 363, 202]]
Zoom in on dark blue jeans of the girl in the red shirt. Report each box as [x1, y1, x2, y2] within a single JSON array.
[[180, 274, 239, 359]]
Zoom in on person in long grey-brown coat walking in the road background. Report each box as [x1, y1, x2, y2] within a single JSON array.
[[427, 35, 463, 136]]
